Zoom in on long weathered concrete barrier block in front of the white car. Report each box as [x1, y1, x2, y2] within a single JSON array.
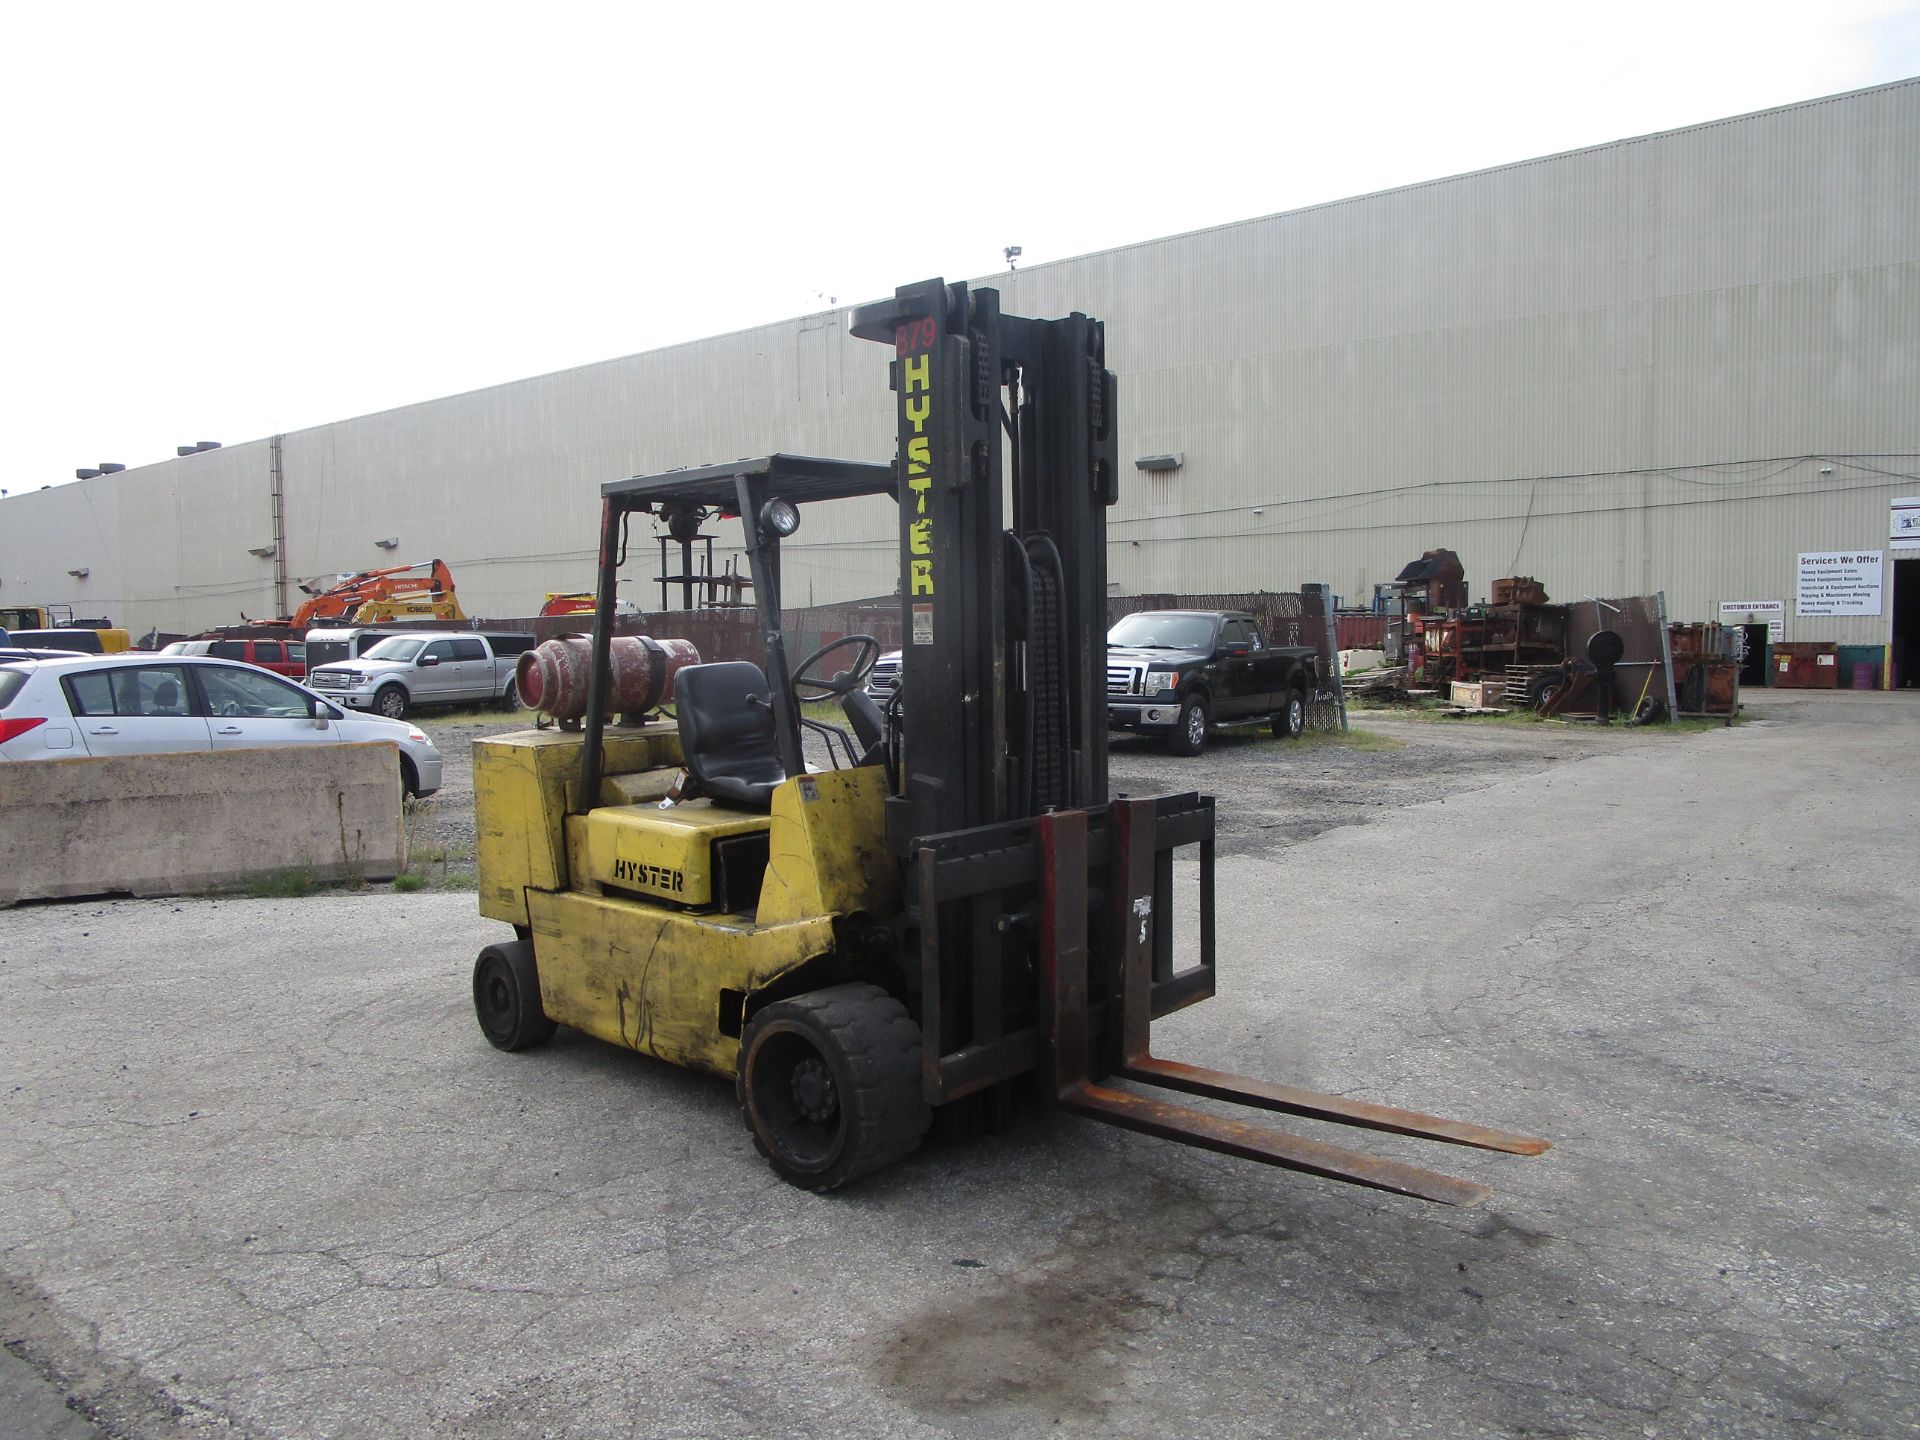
[[0, 743, 407, 908]]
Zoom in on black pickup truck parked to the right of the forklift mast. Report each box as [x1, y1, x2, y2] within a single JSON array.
[[1106, 611, 1315, 755]]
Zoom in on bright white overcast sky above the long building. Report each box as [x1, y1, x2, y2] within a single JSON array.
[[0, 0, 1920, 495]]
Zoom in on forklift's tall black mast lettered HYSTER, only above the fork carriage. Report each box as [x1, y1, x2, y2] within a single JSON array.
[[852, 280, 1119, 858]]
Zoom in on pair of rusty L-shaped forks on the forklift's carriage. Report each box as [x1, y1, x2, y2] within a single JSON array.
[[1033, 799, 1548, 1206]]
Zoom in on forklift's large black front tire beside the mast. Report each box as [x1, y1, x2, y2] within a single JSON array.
[[737, 985, 933, 1190]]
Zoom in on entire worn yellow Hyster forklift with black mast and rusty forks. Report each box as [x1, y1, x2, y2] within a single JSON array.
[[472, 280, 1548, 1204]]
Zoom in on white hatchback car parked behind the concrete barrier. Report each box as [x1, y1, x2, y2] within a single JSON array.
[[0, 651, 440, 795]]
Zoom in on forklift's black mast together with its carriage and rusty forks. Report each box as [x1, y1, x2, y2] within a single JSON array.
[[852, 280, 1546, 1204]]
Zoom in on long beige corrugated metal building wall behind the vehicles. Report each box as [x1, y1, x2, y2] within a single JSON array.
[[0, 81, 1920, 656]]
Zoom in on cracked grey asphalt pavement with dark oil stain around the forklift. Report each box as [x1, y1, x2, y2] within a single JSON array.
[[0, 695, 1920, 1440]]
